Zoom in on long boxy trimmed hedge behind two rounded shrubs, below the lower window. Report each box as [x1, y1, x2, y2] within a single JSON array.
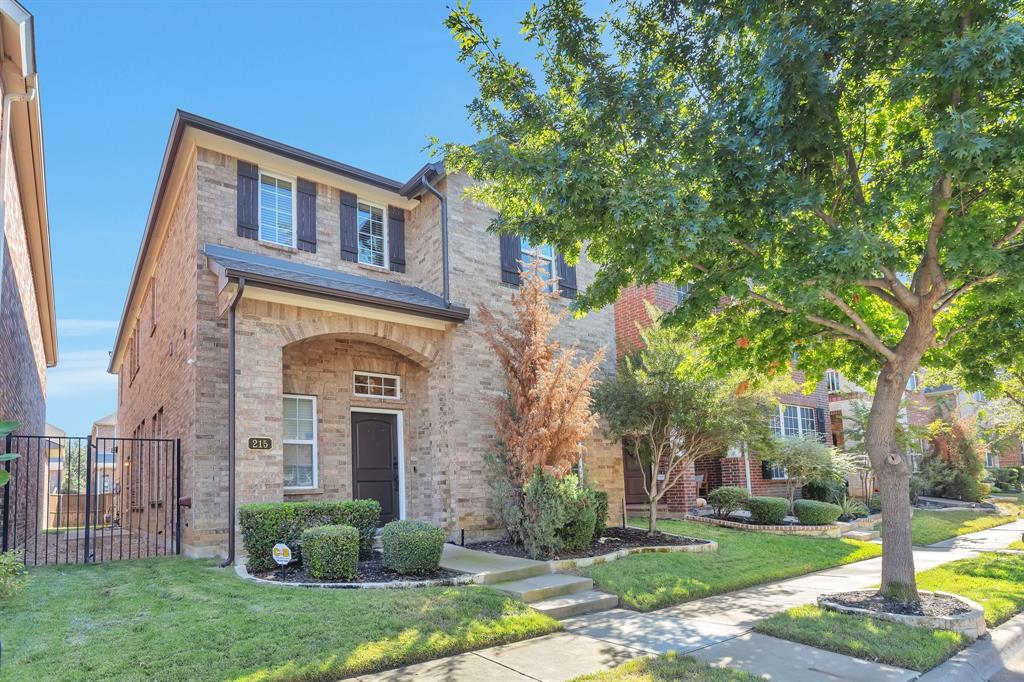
[[239, 500, 381, 570]]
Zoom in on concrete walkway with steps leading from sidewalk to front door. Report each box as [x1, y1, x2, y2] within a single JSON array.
[[441, 545, 618, 621]]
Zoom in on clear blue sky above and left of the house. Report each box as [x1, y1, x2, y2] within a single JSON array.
[[35, 0, 529, 435]]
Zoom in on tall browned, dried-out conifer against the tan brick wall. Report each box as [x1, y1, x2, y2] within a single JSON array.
[[480, 263, 604, 542]]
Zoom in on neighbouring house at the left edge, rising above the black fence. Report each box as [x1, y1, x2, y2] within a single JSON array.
[[0, 0, 57, 435]]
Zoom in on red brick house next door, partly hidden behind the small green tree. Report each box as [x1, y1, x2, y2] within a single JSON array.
[[615, 283, 833, 512]]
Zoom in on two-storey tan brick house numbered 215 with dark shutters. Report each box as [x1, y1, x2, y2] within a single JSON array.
[[110, 112, 623, 555]]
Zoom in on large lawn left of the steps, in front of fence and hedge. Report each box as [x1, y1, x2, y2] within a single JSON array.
[[0, 557, 559, 682]]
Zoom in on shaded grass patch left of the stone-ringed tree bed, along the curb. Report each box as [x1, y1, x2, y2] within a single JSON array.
[[754, 605, 970, 672]]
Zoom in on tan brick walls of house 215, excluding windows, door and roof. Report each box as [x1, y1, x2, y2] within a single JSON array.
[[115, 125, 623, 555]]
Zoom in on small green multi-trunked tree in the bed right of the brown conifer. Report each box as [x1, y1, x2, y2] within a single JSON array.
[[595, 310, 771, 535]]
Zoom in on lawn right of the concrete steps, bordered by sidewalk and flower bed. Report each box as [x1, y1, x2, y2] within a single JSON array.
[[583, 520, 882, 611]]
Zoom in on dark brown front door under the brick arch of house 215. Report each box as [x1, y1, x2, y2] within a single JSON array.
[[352, 412, 398, 523]]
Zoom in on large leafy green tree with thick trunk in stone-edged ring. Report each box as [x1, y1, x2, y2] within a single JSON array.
[[440, 0, 1024, 601]]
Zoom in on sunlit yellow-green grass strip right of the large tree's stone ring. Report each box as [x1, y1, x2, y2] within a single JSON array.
[[918, 553, 1024, 628]]
